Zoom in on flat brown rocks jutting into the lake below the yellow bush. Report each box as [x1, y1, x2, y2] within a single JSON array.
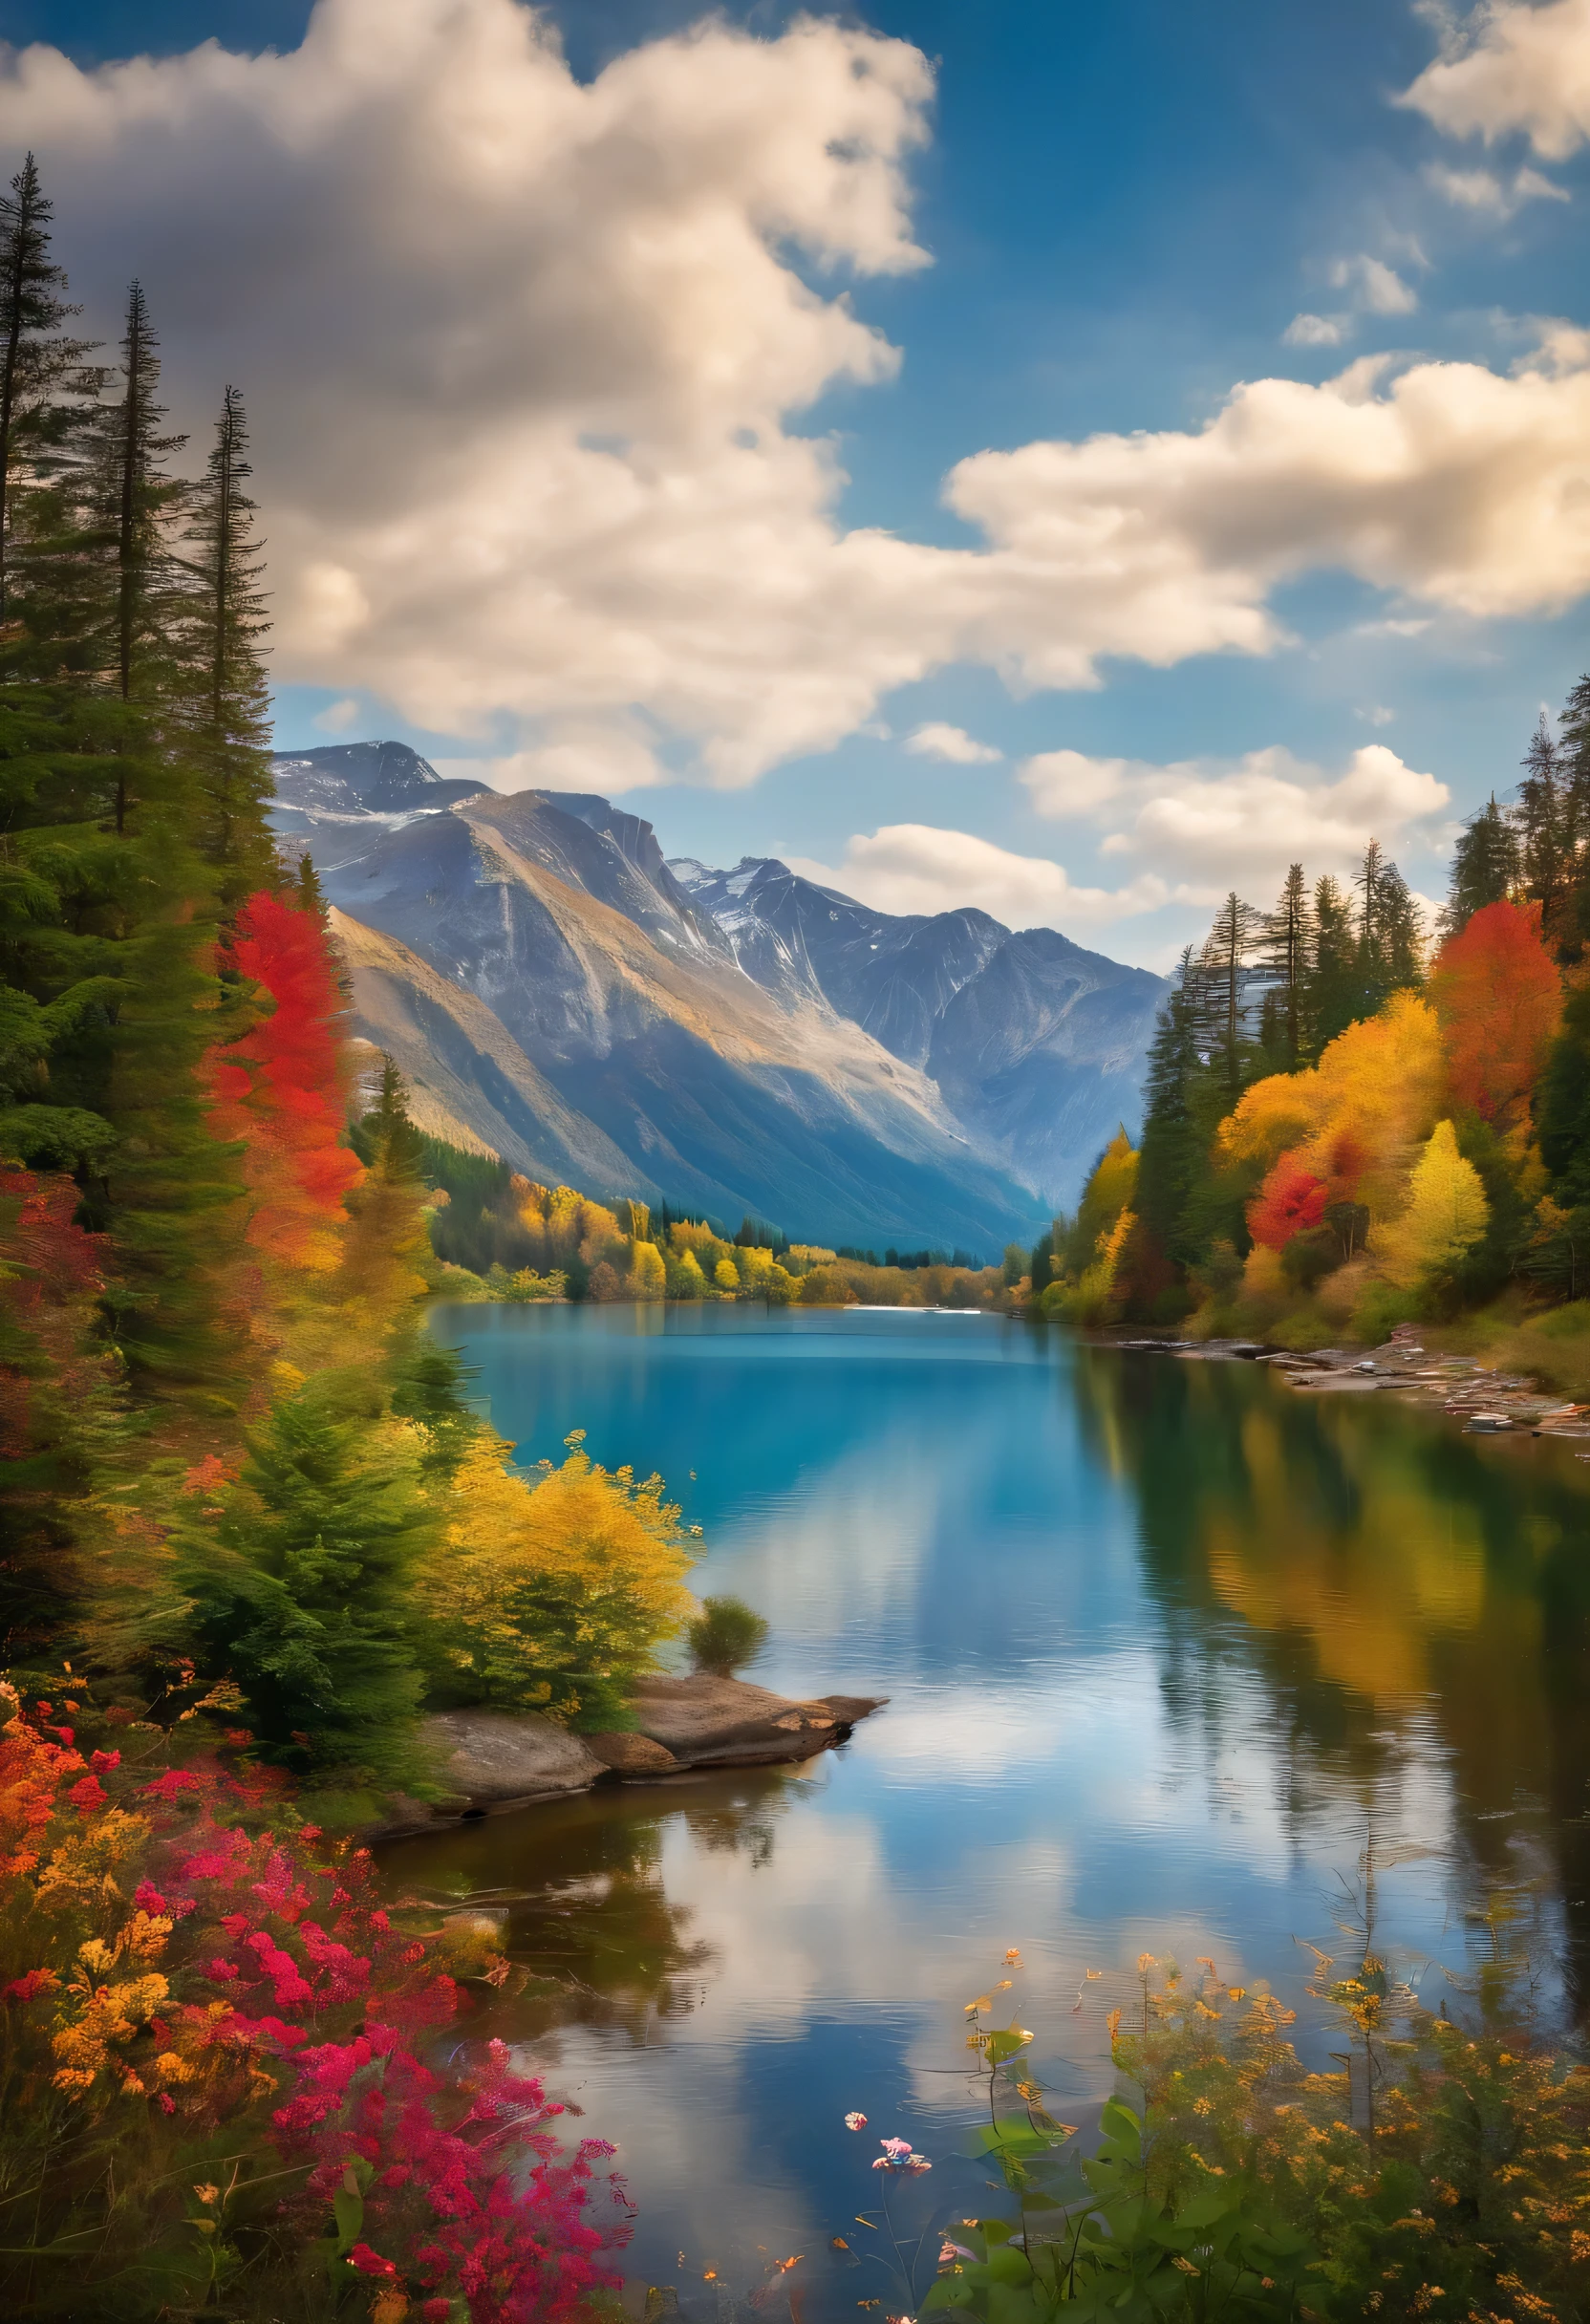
[[378, 1675, 888, 1840]]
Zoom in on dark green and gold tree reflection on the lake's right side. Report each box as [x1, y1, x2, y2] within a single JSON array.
[[1074, 1350, 1590, 2015]]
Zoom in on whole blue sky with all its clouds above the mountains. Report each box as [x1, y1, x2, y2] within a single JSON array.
[[0, 0, 1590, 967]]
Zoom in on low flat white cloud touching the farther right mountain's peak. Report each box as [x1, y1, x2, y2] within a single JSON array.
[[785, 823, 1170, 930]]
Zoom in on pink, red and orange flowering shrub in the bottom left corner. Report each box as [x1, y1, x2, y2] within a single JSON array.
[[0, 1675, 632, 2324]]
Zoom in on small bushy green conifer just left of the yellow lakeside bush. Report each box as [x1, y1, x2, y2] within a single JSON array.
[[182, 1385, 430, 1782]]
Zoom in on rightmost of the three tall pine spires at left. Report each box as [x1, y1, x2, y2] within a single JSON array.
[[186, 388, 274, 904]]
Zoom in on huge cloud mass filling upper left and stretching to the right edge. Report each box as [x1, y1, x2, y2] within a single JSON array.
[[0, 0, 1590, 787]]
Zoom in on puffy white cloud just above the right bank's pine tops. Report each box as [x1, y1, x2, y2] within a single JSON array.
[[1021, 742, 1450, 904]]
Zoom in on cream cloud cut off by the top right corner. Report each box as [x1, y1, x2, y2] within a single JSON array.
[[1400, 0, 1590, 161]]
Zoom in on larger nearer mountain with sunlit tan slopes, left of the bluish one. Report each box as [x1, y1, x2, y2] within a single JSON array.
[[279, 743, 1039, 1255]]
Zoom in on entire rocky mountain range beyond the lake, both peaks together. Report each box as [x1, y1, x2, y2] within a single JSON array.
[[276, 743, 1162, 1255]]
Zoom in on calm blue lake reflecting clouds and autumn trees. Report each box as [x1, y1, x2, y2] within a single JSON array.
[[386, 1303, 1590, 2324]]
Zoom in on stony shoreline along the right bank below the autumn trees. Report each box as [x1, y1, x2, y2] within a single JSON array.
[[1111, 1324, 1590, 1436]]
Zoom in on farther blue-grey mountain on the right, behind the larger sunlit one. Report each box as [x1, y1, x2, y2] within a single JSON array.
[[672, 857, 1167, 1201]]
